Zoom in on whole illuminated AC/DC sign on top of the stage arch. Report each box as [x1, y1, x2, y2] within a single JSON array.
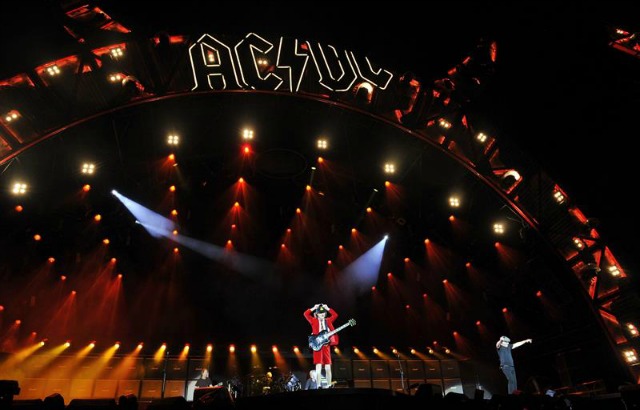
[[189, 33, 393, 93]]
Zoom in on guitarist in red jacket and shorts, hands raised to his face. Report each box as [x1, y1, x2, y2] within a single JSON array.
[[304, 304, 338, 388]]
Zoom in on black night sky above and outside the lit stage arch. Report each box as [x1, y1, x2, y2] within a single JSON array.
[[0, 0, 640, 278]]
